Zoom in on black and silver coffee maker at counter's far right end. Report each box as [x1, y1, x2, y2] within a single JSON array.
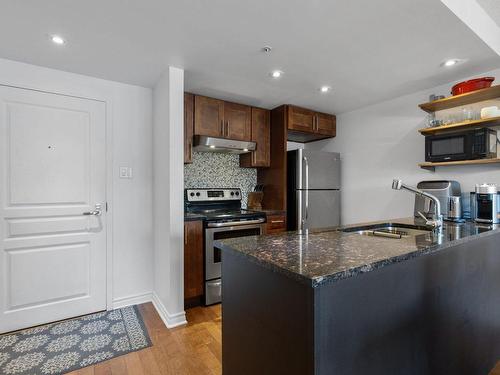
[[471, 183, 500, 224]]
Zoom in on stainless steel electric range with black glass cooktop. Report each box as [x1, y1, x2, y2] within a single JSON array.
[[184, 189, 266, 305]]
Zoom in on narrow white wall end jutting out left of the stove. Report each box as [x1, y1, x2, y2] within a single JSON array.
[[153, 67, 186, 328]]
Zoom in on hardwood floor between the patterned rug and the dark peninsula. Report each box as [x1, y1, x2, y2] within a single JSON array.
[[66, 303, 222, 375]]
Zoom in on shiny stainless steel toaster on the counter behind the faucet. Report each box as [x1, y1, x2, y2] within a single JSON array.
[[414, 180, 463, 221]]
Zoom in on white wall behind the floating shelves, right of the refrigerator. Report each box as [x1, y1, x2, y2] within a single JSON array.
[[306, 69, 500, 224]]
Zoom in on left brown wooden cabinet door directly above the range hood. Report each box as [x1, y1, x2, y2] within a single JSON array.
[[194, 95, 224, 137]]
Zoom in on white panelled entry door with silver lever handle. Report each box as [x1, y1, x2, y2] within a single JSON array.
[[0, 86, 106, 333]]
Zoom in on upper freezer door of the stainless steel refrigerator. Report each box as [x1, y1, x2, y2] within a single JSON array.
[[296, 150, 340, 189]]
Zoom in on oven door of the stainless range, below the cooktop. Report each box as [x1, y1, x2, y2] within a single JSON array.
[[205, 224, 264, 281]]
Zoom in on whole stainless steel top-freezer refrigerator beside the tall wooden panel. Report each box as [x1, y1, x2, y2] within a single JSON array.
[[287, 150, 340, 233]]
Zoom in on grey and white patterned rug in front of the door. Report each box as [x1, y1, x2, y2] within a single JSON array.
[[0, 306, 151, 375]]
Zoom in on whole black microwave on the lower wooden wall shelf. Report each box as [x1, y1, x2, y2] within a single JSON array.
[[425, 128, 498, 162]]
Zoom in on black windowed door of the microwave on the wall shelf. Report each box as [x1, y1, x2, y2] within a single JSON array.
[[425, 132, 472, 162]]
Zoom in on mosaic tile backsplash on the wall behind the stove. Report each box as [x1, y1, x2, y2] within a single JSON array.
[[184, 152, 257, 207]]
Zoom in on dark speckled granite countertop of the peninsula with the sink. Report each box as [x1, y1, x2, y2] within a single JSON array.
[[216, 218, 500, 287]]
